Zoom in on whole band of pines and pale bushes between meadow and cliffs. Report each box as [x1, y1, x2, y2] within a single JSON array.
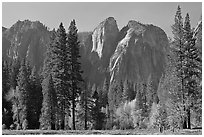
[[2, 6, 202, 132]]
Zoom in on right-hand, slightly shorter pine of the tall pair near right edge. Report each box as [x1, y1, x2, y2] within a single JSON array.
[[183, 13, 201, 129]]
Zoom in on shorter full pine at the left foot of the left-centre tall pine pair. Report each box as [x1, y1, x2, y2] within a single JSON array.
[[40, 75, 57, 130]]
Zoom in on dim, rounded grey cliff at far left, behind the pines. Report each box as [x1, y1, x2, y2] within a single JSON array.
[[2, 20, 50, 70]]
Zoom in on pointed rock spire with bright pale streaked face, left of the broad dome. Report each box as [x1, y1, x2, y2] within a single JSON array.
[[82, 17, 119, 85]]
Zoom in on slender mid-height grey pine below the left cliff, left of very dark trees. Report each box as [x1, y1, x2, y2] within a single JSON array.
[[17, 59, 30, 126]]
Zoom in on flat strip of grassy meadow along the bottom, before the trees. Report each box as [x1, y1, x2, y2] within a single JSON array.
[[2, 129, 202, 135]]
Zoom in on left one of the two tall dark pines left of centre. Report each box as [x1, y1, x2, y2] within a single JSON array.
[[50, 23, 70, 129]]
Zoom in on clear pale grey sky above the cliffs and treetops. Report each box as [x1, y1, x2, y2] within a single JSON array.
[[2, 2, 202, 36]]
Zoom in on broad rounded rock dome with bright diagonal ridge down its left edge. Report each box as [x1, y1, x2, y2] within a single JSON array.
[[109, 21, 168, 85]]
